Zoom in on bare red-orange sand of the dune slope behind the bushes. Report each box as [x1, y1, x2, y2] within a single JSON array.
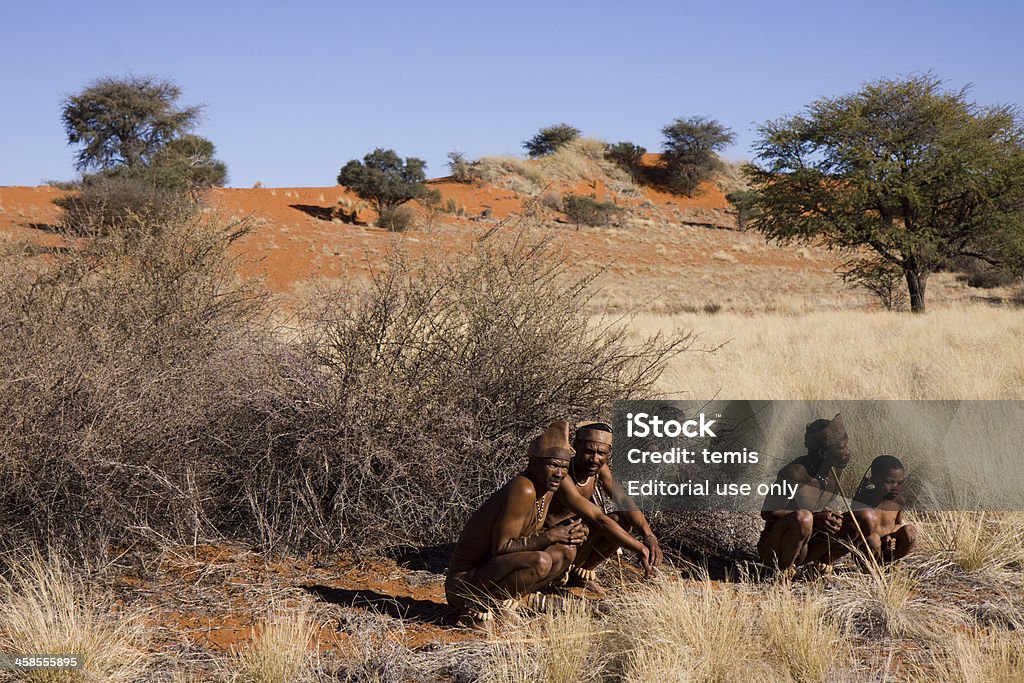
[[0, 178, 837, 312]]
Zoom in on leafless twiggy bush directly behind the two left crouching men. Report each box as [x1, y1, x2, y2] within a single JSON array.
[[280, 237, 687, 545]]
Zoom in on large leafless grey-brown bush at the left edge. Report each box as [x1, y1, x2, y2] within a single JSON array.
[[0, 217, 281, 555]]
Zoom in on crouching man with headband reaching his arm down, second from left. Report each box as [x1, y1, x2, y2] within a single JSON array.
[[545, 422, 663, 597]]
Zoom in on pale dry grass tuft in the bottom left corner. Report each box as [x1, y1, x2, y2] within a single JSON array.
[[0, 554, 148, 683]]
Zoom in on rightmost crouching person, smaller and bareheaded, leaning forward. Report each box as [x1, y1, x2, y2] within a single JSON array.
[[843, 456, 918, 562]]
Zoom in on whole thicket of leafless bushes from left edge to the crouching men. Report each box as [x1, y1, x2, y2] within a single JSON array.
[[0, 216, 686, 557]]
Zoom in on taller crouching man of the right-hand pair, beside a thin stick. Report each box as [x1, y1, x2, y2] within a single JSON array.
[[758, 414, 850, 569]]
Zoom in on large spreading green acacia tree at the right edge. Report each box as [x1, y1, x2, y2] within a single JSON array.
[[745, 74, 1024, 312]]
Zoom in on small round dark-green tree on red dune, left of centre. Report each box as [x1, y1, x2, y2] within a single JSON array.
[[338, 147, 440, 225]]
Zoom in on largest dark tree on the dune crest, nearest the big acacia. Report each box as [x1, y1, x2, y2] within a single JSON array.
[[662, 116, 736, 197]]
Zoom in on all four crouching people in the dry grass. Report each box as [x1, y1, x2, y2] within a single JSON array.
[[444, 415, 914, 623]]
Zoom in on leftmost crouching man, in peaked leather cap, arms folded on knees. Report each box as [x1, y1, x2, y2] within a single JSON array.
[[444, 422, 587, 622]]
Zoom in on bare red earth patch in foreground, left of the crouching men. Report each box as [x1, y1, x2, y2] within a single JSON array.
[[123, 546, 480, 656]]
